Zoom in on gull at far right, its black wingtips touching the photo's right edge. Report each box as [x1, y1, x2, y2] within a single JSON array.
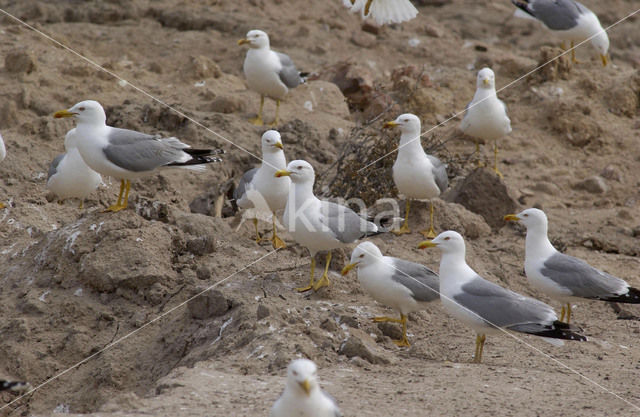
[[504, 208, 640, 323]]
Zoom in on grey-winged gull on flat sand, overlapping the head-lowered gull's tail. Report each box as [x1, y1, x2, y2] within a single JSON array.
[[418, 230, 587, 363]]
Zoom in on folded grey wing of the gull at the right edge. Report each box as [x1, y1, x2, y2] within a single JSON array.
[[540, 253, 629, 298]]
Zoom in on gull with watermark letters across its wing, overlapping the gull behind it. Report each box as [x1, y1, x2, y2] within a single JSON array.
[[275, 161, 382, 292]]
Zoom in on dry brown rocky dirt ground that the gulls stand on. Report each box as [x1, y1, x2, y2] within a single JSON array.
[[0, 0, 640, 416]]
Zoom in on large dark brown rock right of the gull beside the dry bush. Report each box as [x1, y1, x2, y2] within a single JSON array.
[[448, 168, 517, 234]]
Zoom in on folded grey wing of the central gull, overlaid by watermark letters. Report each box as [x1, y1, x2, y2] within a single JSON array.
[[320, 201, 378, 243]]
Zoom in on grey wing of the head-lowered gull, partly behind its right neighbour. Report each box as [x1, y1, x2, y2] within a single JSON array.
[[391, 258, 440, 301]]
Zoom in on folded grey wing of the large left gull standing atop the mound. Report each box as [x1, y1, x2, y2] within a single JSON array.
[[103, 128, 190, 172]]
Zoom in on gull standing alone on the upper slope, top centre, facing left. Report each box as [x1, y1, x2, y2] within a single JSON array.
[[238, 30, 304, 126]]
